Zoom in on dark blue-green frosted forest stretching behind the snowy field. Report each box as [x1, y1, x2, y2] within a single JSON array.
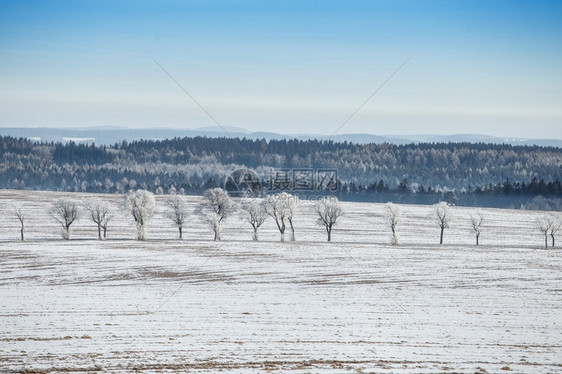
[[0, 137, 562, 210]]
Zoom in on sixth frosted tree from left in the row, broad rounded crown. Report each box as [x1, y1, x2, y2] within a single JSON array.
[[200, 187, 234, 240]]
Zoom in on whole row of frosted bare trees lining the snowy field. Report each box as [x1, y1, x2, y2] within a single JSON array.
[[5, 188, 562, 248]]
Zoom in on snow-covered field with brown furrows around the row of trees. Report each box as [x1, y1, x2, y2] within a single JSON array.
[[0, 190, 562, 373]]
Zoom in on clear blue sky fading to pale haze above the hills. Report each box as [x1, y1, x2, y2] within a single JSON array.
[[0, 0, 562, 139]]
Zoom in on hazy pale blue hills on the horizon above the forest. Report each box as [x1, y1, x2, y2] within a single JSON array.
[[0, 126, 562, 148]]
